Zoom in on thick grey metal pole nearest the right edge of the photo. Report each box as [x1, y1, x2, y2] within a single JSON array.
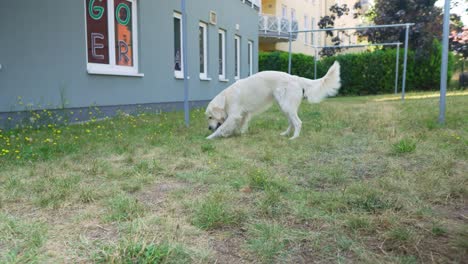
[[439, 0, 450, 124]]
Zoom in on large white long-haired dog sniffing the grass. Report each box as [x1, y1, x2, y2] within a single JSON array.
[[206, 62, 341, 139]]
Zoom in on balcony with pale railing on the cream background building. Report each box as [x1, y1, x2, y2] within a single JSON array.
[[258, 14, 298, 43]]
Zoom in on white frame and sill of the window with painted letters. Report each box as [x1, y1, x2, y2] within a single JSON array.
[[84, 0, 144, 77]]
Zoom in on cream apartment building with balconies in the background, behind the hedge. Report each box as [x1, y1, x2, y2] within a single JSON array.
[[259, 0, 370, 55]]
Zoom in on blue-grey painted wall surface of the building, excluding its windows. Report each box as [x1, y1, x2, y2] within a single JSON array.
[[0, 0, 258, 115]]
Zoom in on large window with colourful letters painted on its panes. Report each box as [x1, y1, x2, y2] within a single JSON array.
[[85, 0, 143, 76]]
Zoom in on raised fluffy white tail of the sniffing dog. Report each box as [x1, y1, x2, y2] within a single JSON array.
[[300, 61, 341, 103]]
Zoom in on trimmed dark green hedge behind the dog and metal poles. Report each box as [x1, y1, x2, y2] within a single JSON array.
[[259, 41, 453, 95]]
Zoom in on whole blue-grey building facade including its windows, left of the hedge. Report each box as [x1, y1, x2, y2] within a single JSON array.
[[0, 0, 259, 127]]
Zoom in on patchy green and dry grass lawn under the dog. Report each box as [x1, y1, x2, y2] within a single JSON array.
[[0, 93, 468, 263]]
